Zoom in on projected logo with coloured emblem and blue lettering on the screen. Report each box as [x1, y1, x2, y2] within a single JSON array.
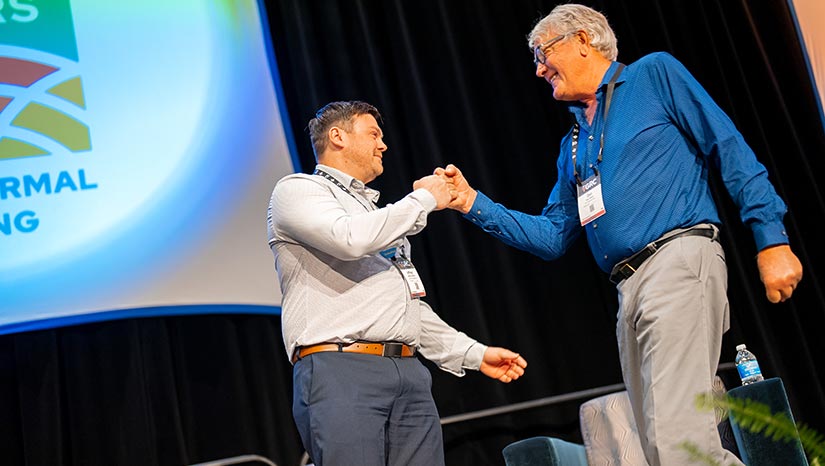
[[0, 0, 97, 238]]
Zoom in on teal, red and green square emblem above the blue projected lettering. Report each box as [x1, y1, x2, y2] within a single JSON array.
[[0, 0, 91, 160]]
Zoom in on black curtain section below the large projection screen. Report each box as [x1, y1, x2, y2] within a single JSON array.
[[0, 315, 303, 466]]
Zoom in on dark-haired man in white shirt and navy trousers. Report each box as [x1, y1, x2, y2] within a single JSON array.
[[267, 101, 527, 466]]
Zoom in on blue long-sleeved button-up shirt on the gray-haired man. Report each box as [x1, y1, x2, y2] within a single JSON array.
[[465, 53, 788, 272]]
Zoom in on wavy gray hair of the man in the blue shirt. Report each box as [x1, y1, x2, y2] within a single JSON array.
[[527, 3, 619, 61]]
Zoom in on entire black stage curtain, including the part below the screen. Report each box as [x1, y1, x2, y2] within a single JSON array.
[[0, 0, 825, 466]]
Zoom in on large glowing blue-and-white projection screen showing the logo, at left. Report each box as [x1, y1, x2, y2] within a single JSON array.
[[0, 0, 297, 333]]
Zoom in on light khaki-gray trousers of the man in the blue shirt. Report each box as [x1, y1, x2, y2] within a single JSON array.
[[616, 225, 742, 466]]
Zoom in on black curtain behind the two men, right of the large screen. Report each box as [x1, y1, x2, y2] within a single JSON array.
[[266, 0, 825, 464]]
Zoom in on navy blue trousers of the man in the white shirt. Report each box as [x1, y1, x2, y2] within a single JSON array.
[[292, 352, 444, 466]]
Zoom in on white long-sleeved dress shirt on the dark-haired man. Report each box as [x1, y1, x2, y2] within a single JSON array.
[[267, 165, 487, 375]]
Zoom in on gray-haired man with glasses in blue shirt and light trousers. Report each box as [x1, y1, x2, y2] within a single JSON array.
[[436, 4, 802, 466]]
